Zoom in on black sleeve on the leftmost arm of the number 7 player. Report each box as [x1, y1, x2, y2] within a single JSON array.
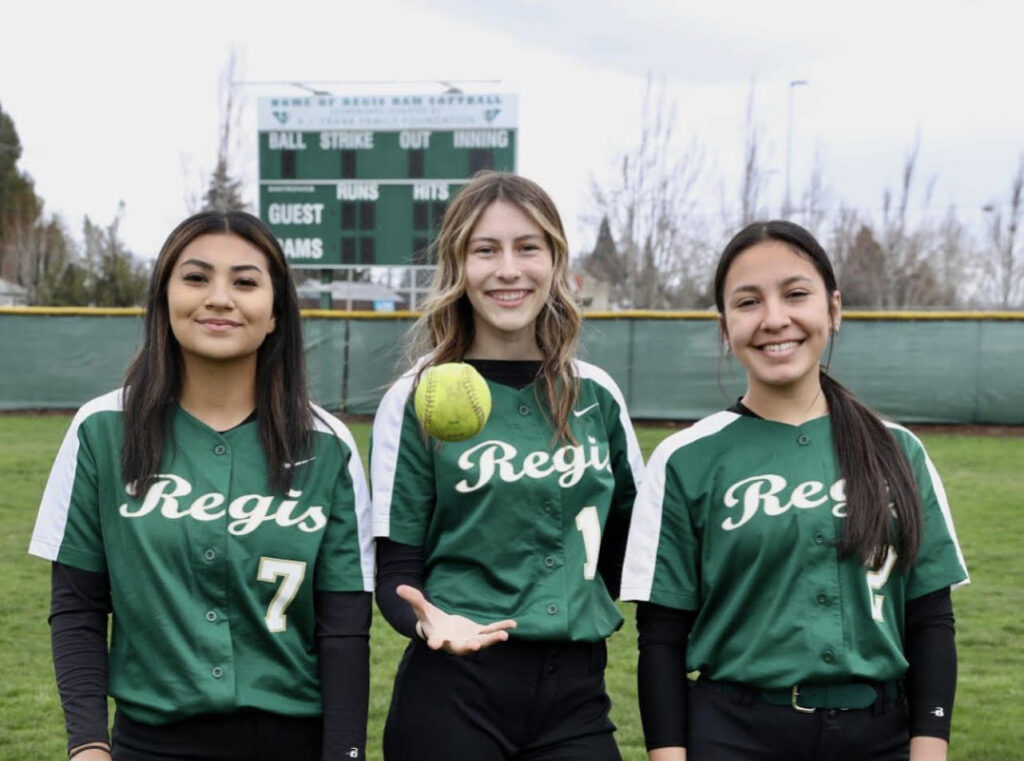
[[49, 562, 111, 749]]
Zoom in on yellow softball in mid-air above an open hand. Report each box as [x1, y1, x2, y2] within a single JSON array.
[[413, 362, 490, 441]]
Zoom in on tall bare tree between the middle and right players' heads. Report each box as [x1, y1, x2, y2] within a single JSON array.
[[584, 77, 708, 309]]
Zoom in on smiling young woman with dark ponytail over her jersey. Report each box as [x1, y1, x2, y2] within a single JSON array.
[[622, 221, 968, 761]]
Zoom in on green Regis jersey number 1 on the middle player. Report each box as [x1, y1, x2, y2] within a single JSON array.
[[370, 362, 643, 641]]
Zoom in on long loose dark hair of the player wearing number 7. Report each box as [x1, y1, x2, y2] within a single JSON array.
[[121, 211, 313, 495]]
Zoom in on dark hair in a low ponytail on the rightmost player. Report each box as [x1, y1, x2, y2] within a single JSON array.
[[715, 220, 922, 570]]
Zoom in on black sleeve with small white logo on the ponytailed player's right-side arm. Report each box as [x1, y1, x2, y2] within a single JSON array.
[[903, 587, 956, 741]]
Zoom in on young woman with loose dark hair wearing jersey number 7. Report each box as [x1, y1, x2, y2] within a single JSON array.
[[30, 212, 373, 761]]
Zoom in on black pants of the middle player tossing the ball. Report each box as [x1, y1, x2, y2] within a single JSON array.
[[384, 640, 622, 761]]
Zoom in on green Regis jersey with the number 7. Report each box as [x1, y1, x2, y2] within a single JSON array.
[[29, 390, 373, 724]]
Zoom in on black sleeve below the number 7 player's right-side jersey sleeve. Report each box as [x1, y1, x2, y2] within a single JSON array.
[[313, 591, 373, 761]]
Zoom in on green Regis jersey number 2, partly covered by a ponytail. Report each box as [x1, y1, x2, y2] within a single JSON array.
[[622, 412, 968, 688]]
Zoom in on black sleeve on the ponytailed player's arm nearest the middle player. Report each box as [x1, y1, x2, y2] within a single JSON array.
[[637, 602, 696, 751]]
